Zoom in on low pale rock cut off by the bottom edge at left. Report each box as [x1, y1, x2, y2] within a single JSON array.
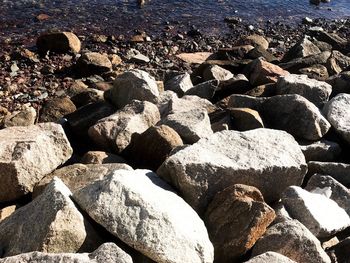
[[0, 243, 133, 263]]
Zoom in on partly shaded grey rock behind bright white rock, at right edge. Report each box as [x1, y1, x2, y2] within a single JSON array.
[[305, 174, 350, 215]]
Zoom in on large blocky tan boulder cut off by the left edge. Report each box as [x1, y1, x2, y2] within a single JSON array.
[[0, 123, 73, 202]]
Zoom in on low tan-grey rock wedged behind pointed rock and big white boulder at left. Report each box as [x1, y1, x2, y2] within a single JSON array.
[[33, 163, 132, 197]]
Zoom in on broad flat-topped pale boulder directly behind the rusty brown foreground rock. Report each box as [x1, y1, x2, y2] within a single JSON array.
[[157, 129, 306, 214]]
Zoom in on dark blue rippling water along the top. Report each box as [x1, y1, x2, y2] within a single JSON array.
[[0, 0, 350, 37]]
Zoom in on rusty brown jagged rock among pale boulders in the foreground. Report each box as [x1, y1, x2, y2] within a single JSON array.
[[205, 184, 275, 263]]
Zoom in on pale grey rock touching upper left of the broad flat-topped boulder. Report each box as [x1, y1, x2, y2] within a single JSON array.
[[160, 109, 213, 144]]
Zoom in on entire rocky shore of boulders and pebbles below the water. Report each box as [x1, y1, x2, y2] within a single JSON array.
[[0, 17, 350, 263]]
